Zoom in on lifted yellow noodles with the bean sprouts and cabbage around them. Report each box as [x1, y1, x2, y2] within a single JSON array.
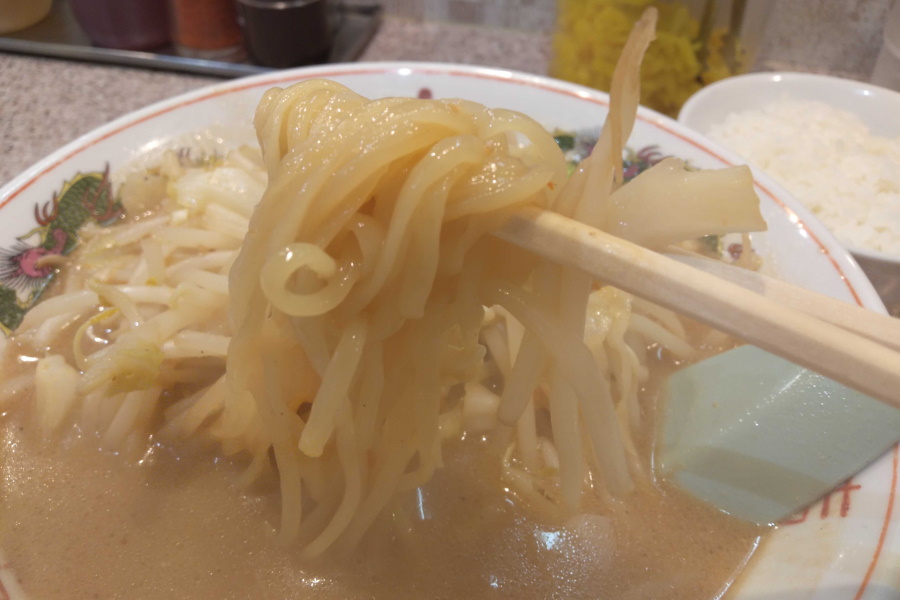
[[0, 12, 764, 557]]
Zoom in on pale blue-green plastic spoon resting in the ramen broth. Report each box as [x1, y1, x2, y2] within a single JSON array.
[[656, 346, 900, 523]]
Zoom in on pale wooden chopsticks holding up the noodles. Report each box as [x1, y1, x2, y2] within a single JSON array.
[[497, 208, 900, 408]]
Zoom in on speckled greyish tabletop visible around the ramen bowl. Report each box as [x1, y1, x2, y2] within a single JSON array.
[[0, 17, 900, 316]]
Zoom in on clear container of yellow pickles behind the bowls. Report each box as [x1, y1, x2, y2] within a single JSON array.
[[550, 0, 771, 117]]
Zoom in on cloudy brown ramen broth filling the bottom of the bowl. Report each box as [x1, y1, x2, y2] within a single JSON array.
[[0, 390, 761, 600]]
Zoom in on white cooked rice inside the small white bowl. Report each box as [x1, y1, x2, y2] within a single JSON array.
[[709, 99, 900, 255]]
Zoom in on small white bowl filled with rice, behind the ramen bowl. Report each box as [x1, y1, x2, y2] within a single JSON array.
[[678, 73, 900, 316]]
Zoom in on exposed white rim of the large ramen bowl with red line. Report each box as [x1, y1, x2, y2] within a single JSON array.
[[0, 63, 900, 600]]
